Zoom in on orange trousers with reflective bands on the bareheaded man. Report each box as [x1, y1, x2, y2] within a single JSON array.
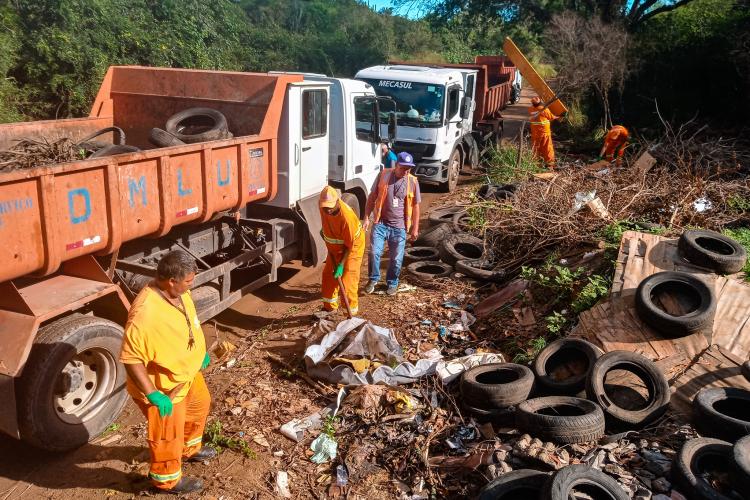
[[135, 372, 211, 489]]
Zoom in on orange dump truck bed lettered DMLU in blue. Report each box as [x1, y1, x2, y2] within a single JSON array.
[[0, 66, 302, 282]]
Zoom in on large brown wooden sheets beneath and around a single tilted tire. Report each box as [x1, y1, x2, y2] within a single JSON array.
[[573, 231, 750, 360]]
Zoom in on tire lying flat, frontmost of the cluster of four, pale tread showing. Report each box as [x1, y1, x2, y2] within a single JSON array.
[[516, 396, 604, 444]]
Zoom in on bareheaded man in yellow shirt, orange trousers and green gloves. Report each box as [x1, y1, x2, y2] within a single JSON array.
[[120, 250, 216, 494]]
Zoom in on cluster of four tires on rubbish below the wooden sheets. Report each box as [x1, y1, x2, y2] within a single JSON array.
[[460, 338, 670, 444]]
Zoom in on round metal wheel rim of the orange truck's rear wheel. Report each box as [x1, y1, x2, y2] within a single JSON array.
[[52, 347, 117, 424]]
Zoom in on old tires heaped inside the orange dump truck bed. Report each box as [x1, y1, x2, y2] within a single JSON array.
[[148, 108, 229, 148]]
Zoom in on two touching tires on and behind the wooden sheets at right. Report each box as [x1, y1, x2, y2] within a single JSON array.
[[635, 230, 747, 338]]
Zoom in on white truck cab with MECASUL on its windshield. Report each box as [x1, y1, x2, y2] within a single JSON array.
[[356, 65, 477, 191]]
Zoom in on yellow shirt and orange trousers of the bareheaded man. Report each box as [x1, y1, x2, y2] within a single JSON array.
[[120, 286, 211, 489]]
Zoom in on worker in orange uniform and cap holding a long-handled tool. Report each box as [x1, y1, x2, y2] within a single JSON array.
[[319, 186, 365, 315]]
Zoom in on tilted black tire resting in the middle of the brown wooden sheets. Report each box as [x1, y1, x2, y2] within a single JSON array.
[[635, 271, 716, 337]]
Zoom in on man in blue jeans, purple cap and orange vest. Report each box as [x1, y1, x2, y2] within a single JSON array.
[[362, 152, 422, 295]]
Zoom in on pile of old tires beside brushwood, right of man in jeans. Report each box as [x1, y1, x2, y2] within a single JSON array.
[[404, 206, 505, 284]]
